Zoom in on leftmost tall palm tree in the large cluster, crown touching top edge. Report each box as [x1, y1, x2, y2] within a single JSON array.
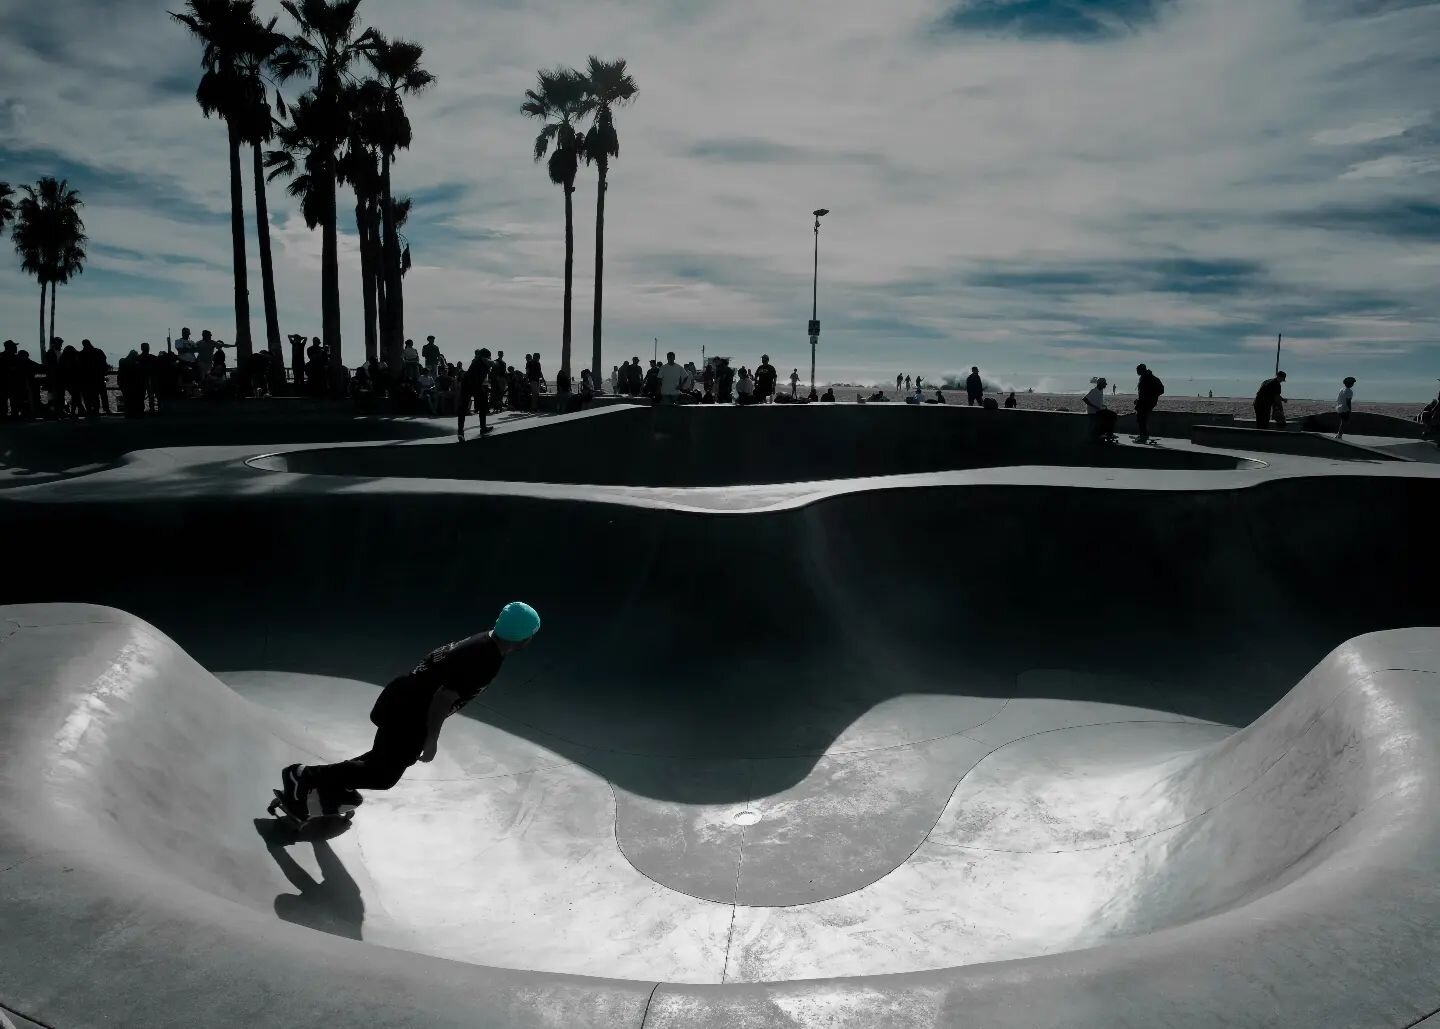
[[170, 0, 256, 374]]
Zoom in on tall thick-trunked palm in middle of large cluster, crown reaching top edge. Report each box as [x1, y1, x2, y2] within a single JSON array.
[[271, 0, 374, 367]]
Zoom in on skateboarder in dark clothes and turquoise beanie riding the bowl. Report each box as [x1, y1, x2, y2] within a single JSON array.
[[278, 602, 540, 822]]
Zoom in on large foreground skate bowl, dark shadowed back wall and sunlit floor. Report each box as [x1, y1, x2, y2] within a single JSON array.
[[0, 412, 1440, 1028]]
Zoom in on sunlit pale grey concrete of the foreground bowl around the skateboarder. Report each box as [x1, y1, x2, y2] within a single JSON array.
[[0, 604, 1440, 1028]]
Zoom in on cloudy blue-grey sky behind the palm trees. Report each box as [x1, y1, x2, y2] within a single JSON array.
[[0, 0, 1440, 400]]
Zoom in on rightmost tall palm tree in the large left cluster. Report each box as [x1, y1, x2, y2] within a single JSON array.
[[366, 33, 435, 379]]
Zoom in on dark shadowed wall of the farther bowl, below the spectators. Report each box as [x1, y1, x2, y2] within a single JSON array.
[[256, 404, 1246, 486]]
